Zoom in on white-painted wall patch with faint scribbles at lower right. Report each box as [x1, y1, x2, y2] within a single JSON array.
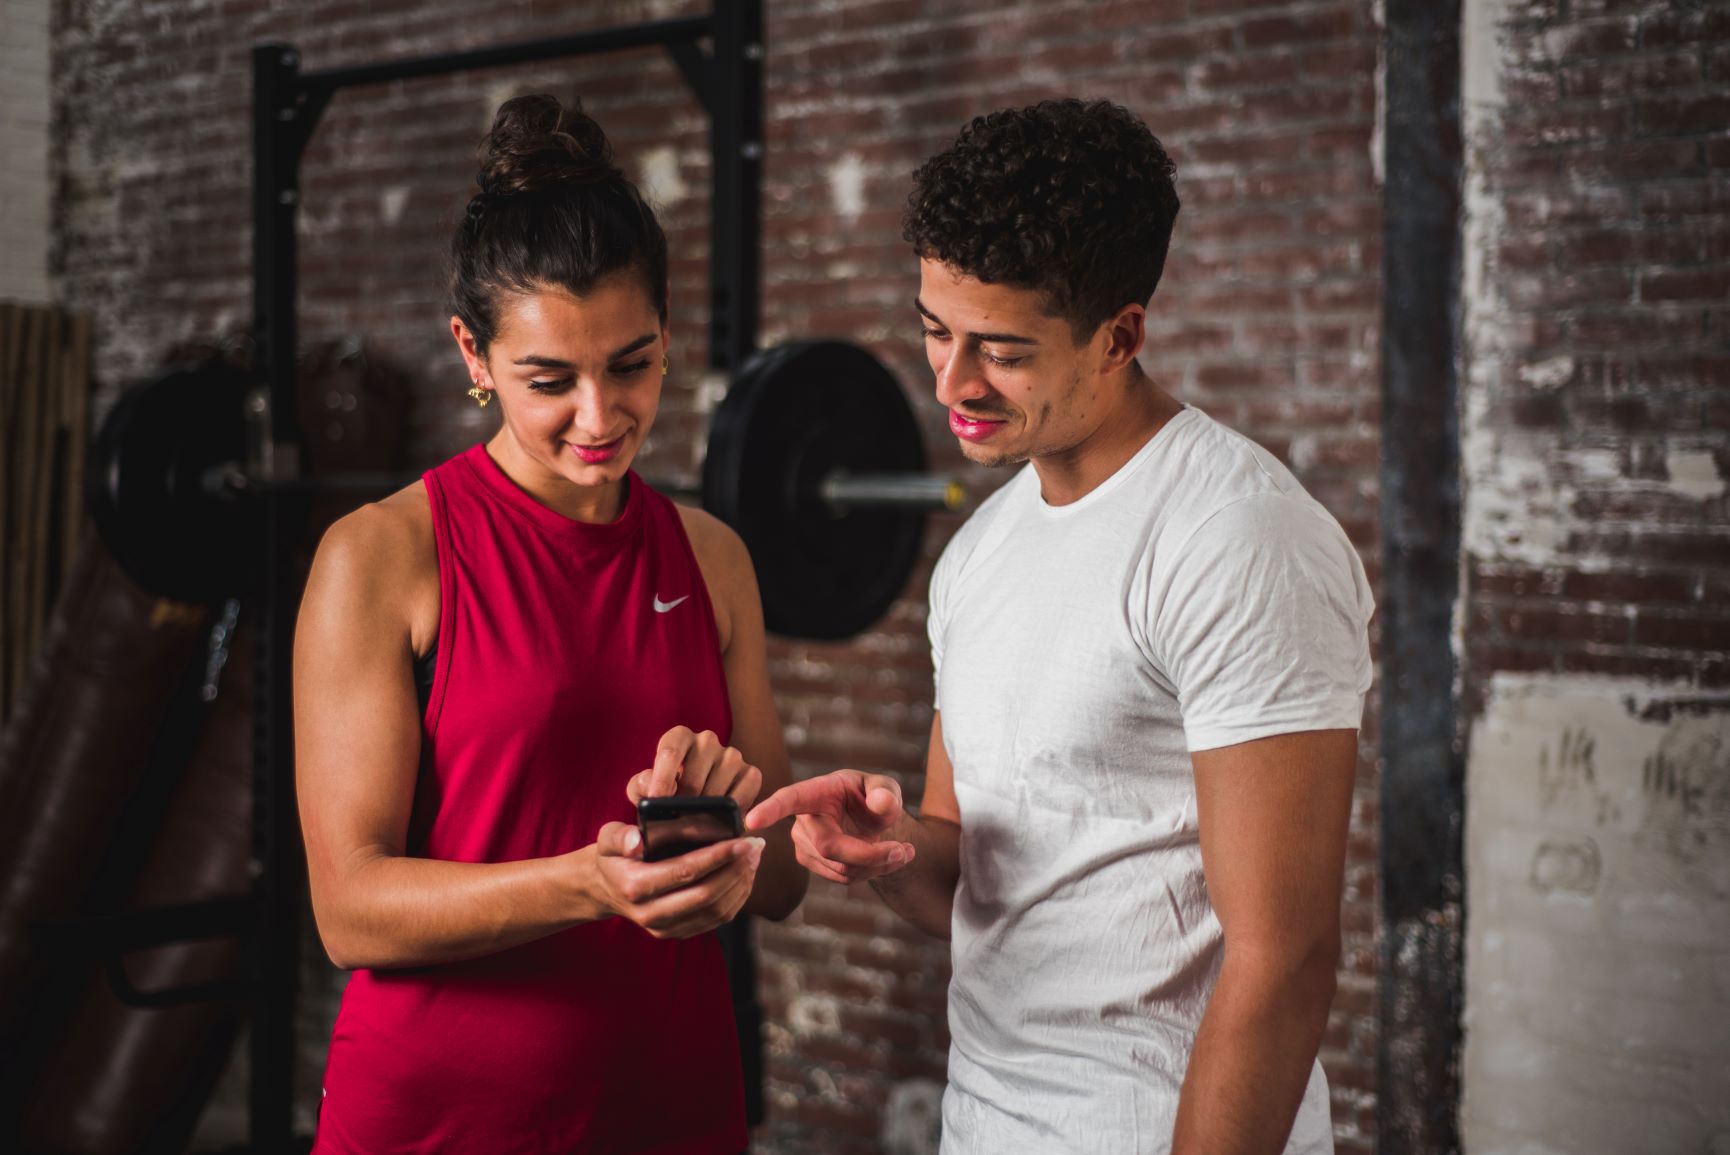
[[1462, 674, 1730, 1155]]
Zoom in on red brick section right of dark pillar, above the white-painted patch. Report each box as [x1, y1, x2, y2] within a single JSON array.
[[1465, 0, 1730, 685]]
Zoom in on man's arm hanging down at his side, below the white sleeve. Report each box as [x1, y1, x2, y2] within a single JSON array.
[[1171, 730, 1358, 1155]]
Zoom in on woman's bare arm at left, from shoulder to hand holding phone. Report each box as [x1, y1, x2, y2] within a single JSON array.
[[294, 486, 761, 968]]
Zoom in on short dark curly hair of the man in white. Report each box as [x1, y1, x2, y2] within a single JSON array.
[[901, 100, 1178, 342]]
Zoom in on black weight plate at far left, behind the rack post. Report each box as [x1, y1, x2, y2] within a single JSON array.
[[85, 361, 261, 602]]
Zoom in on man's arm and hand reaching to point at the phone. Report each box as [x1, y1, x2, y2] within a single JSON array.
[[746, 714, 962, 939]]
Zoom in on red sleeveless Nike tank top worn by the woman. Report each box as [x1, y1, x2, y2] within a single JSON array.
[[313, 446, 747, 1155]]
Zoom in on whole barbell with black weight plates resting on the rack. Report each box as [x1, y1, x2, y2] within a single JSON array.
[[87, 341, 967, 640]]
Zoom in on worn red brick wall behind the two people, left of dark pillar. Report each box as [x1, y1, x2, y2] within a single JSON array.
[[55, 0, 1381, 1153]]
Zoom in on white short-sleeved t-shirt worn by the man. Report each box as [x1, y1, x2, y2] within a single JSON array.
[[931, 408, 1374, 1155]]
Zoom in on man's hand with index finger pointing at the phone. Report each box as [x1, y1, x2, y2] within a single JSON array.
[[746, 769, 913, 884]]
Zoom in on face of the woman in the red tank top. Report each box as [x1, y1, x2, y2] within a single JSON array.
[[452, 270, 668, 501]]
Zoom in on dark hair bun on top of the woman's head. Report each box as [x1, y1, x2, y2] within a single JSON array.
[[476, 95, 623, 197]]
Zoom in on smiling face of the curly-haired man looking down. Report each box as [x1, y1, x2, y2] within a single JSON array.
[[913, 259, 1107, 465]]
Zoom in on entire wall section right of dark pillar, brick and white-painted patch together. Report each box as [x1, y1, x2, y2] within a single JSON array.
[[1460, 0, 1730, 1152]]
